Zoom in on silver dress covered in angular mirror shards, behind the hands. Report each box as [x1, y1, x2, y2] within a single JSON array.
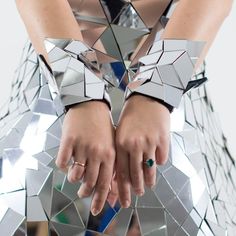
[[0, 0, 236, 236]]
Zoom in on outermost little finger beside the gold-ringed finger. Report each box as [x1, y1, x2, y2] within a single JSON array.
[[56, 137, 74, 169]]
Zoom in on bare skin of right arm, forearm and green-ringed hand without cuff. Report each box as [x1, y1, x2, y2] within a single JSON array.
[[111, 0, 232, 207]]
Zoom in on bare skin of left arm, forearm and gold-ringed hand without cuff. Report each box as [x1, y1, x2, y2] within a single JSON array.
[[16, 0, 115, 215]]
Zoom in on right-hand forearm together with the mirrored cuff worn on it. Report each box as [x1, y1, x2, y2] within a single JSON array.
[[126, 0, 232, 108]]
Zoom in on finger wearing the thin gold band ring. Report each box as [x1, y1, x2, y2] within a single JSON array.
[[68, 147, 86, 183]]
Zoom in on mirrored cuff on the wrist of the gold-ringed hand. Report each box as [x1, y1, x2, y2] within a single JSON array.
[[39, 38, 111, 111]]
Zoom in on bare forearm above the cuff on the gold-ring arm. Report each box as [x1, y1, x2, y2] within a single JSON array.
[[16, 0, 82, 59]]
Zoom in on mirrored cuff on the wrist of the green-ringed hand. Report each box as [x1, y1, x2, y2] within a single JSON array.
[[125, 39, 206, 111]]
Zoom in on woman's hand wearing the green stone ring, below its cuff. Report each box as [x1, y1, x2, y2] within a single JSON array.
[[116, 95, 170, 207]]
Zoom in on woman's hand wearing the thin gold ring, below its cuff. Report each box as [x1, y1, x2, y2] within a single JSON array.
[[56, 101, 115, 215]]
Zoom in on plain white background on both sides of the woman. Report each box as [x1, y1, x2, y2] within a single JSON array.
[[0, 0, 236, 157]]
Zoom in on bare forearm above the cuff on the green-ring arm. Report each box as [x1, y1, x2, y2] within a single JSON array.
[[162, 0, 233, 66]]
